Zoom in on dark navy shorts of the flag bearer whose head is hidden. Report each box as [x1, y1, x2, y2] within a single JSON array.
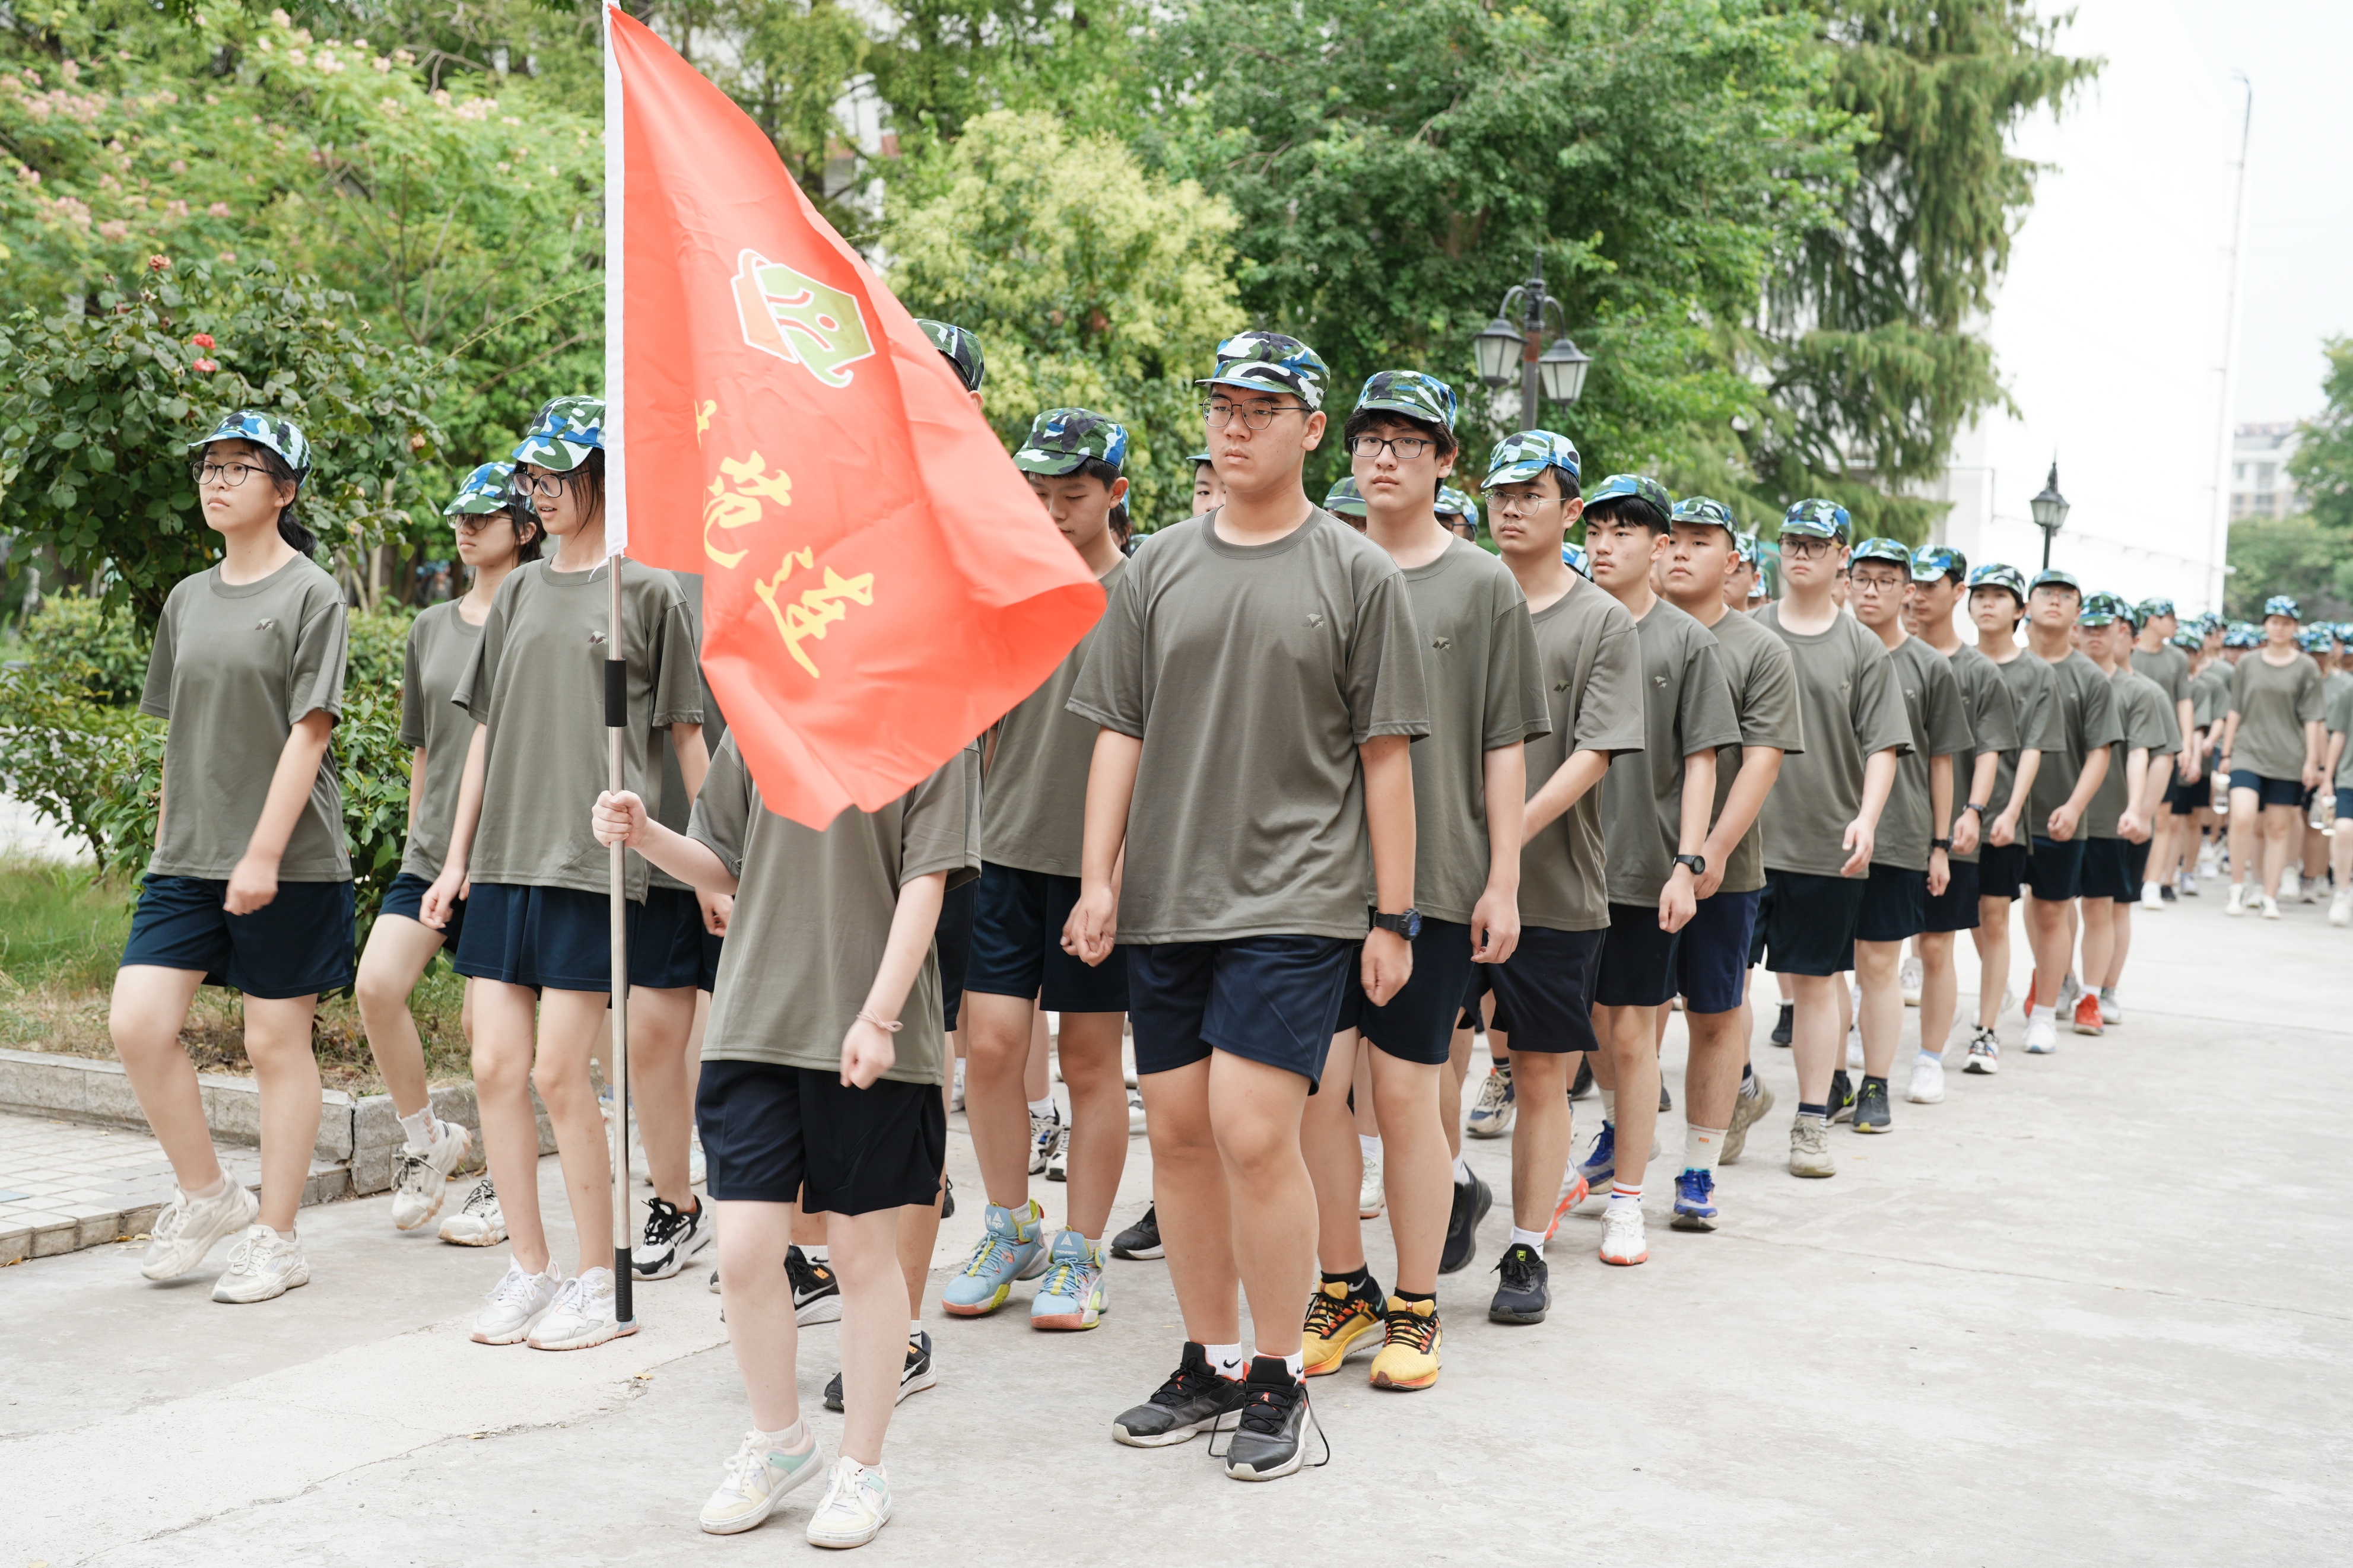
[[694, 1060, 948, 1216]]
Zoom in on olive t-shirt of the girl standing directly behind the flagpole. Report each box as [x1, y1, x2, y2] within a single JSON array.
[[449, 557, 704, 903]]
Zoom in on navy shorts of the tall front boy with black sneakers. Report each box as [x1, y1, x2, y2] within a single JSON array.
[[1125, 936, 1360, 1084]]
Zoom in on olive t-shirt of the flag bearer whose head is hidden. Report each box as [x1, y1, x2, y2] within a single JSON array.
[[687, 736, 981, 1084]]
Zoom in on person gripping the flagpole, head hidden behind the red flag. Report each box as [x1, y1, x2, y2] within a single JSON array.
[[593, 736, 979, 1547]]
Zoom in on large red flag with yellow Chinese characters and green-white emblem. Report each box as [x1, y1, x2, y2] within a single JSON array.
[[607, 9, 1104, 828]]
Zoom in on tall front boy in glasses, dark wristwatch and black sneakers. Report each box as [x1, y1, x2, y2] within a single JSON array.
[[1063, 332, 1428, 1481]]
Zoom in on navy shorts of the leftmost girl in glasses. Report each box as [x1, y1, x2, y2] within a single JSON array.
[[122, 874, 358, 1001]]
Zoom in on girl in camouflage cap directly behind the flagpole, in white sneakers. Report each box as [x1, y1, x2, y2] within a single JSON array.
[[419, 397, 704, 1349]]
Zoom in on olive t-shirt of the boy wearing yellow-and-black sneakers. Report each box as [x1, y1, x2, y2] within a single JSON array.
[[1365, 536, 1553, 924]]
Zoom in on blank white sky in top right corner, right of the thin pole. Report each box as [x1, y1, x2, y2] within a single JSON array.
[[2179, 0, 2353, 423]]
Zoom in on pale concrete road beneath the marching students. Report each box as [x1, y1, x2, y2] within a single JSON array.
[[0, 898, 2353, 1568]]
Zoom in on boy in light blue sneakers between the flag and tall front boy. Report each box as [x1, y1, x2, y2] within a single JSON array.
[[941, 409, 1127, 1328]]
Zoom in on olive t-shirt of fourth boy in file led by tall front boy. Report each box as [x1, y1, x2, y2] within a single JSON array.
[[1602, 599, 1741, 905]]
